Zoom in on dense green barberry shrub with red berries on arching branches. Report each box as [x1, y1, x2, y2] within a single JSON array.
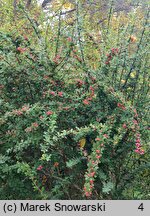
[[0, 1, 150, 199]]
